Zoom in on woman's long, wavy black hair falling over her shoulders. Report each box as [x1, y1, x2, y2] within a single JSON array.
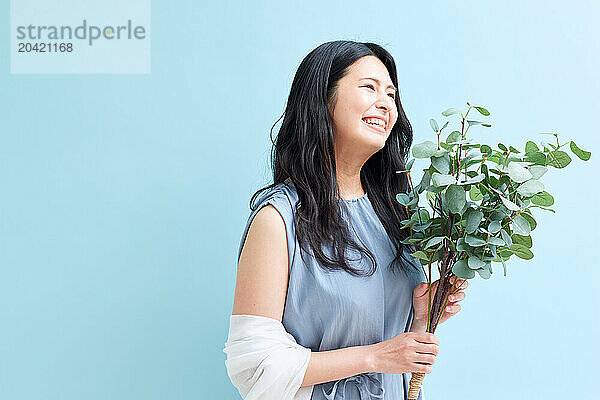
[[250, 40, 418, 276]]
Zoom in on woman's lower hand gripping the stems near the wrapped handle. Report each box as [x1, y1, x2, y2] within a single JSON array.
[[370, 332, 440, 374]]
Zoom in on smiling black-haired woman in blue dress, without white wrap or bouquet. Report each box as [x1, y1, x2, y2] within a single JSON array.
[[225, 41, 466, 400]]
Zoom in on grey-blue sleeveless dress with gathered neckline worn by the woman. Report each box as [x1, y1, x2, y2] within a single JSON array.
[[238, 182, 425, 400]]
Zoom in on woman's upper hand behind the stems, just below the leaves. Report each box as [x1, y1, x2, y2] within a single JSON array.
[[413, 276, 469, 326]]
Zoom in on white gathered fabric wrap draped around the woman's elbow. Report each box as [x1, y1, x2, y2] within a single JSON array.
[[223, 315, 313, 400]]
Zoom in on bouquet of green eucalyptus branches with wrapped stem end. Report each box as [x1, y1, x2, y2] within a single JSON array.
[[396, 102, 591, 399]]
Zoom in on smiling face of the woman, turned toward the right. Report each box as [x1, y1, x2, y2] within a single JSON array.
[[332, 56, 398, 159]]
